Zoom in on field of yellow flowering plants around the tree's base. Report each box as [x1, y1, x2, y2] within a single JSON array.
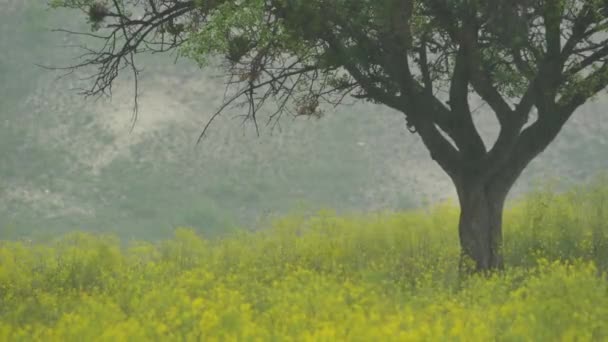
[[0, 183, 608, 341]]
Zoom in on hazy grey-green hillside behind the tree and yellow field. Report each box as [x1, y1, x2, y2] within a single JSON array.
[[0, 0, 608, 239]]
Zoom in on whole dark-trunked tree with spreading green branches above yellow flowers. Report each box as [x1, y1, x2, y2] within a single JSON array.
[[52, 0, 608, 270]]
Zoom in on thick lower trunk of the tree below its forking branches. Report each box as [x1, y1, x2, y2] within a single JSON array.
[[458, 184, 509, 272]]
